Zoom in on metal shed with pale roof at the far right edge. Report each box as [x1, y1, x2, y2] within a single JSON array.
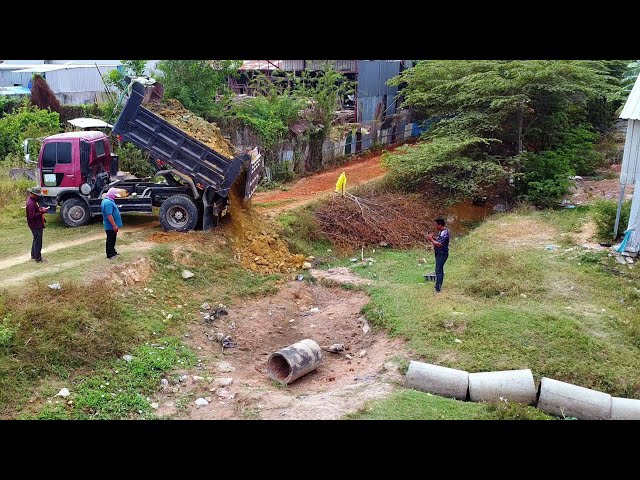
[[616, 77, 640, 254]]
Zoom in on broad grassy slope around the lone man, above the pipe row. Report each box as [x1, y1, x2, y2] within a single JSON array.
[[356, 210, 640, 398]]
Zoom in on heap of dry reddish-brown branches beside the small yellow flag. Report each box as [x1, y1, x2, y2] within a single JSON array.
[[315, 193, 439, 249]]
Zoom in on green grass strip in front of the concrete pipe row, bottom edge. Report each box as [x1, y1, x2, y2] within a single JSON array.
[[345, 390, 553, 420]]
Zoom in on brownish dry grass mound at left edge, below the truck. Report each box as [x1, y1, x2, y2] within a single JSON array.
[[0, 280, 142, 416]]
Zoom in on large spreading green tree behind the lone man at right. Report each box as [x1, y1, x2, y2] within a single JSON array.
[[388, 60, 622, 206]]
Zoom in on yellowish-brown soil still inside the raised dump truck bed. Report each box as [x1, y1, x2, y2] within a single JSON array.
[[145, 98, 234, 157]]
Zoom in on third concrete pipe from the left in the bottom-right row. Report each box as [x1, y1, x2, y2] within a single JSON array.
[[538, 377, 611, 420]]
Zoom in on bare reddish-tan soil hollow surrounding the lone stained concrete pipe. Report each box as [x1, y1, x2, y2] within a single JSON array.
[[155, 282, 405, 419]]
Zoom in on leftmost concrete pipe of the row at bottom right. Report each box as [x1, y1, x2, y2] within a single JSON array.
[[405, 361, 469, 400]]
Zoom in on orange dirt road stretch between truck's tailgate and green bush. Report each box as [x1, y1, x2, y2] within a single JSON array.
[[253, 149, 393, 214]]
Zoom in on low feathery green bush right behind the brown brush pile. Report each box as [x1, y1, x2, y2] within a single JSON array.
[[382, 137, 506, 197]]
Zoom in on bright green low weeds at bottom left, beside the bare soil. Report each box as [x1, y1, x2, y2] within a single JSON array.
[[21, 337, 196, 420]]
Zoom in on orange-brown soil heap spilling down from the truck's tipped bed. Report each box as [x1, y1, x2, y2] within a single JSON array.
[[224, 175, 305, 273]]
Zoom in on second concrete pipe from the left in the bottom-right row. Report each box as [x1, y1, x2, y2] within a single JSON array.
[[469, 369, 536, 405]]
